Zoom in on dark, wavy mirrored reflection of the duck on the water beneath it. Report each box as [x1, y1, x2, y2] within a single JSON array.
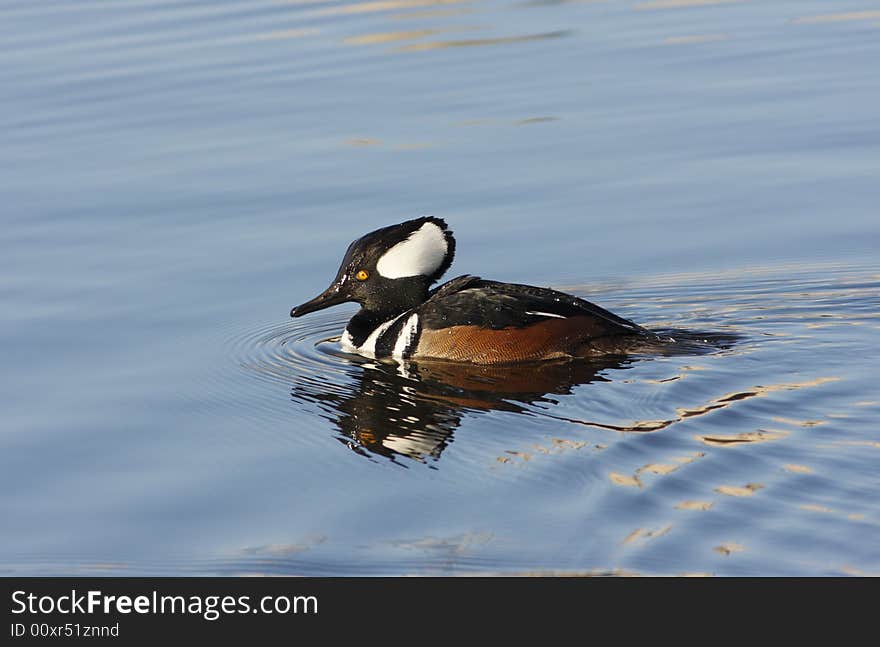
[[291, 356, 633, 462]]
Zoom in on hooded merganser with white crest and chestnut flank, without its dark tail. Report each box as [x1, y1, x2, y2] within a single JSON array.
[[290, 216, 656, 364]]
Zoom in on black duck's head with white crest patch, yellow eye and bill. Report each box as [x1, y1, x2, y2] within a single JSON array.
[[290, 216, 455, 317]]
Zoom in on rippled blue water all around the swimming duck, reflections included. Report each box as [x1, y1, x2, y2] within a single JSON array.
[[0, 0, 880, 575]]
